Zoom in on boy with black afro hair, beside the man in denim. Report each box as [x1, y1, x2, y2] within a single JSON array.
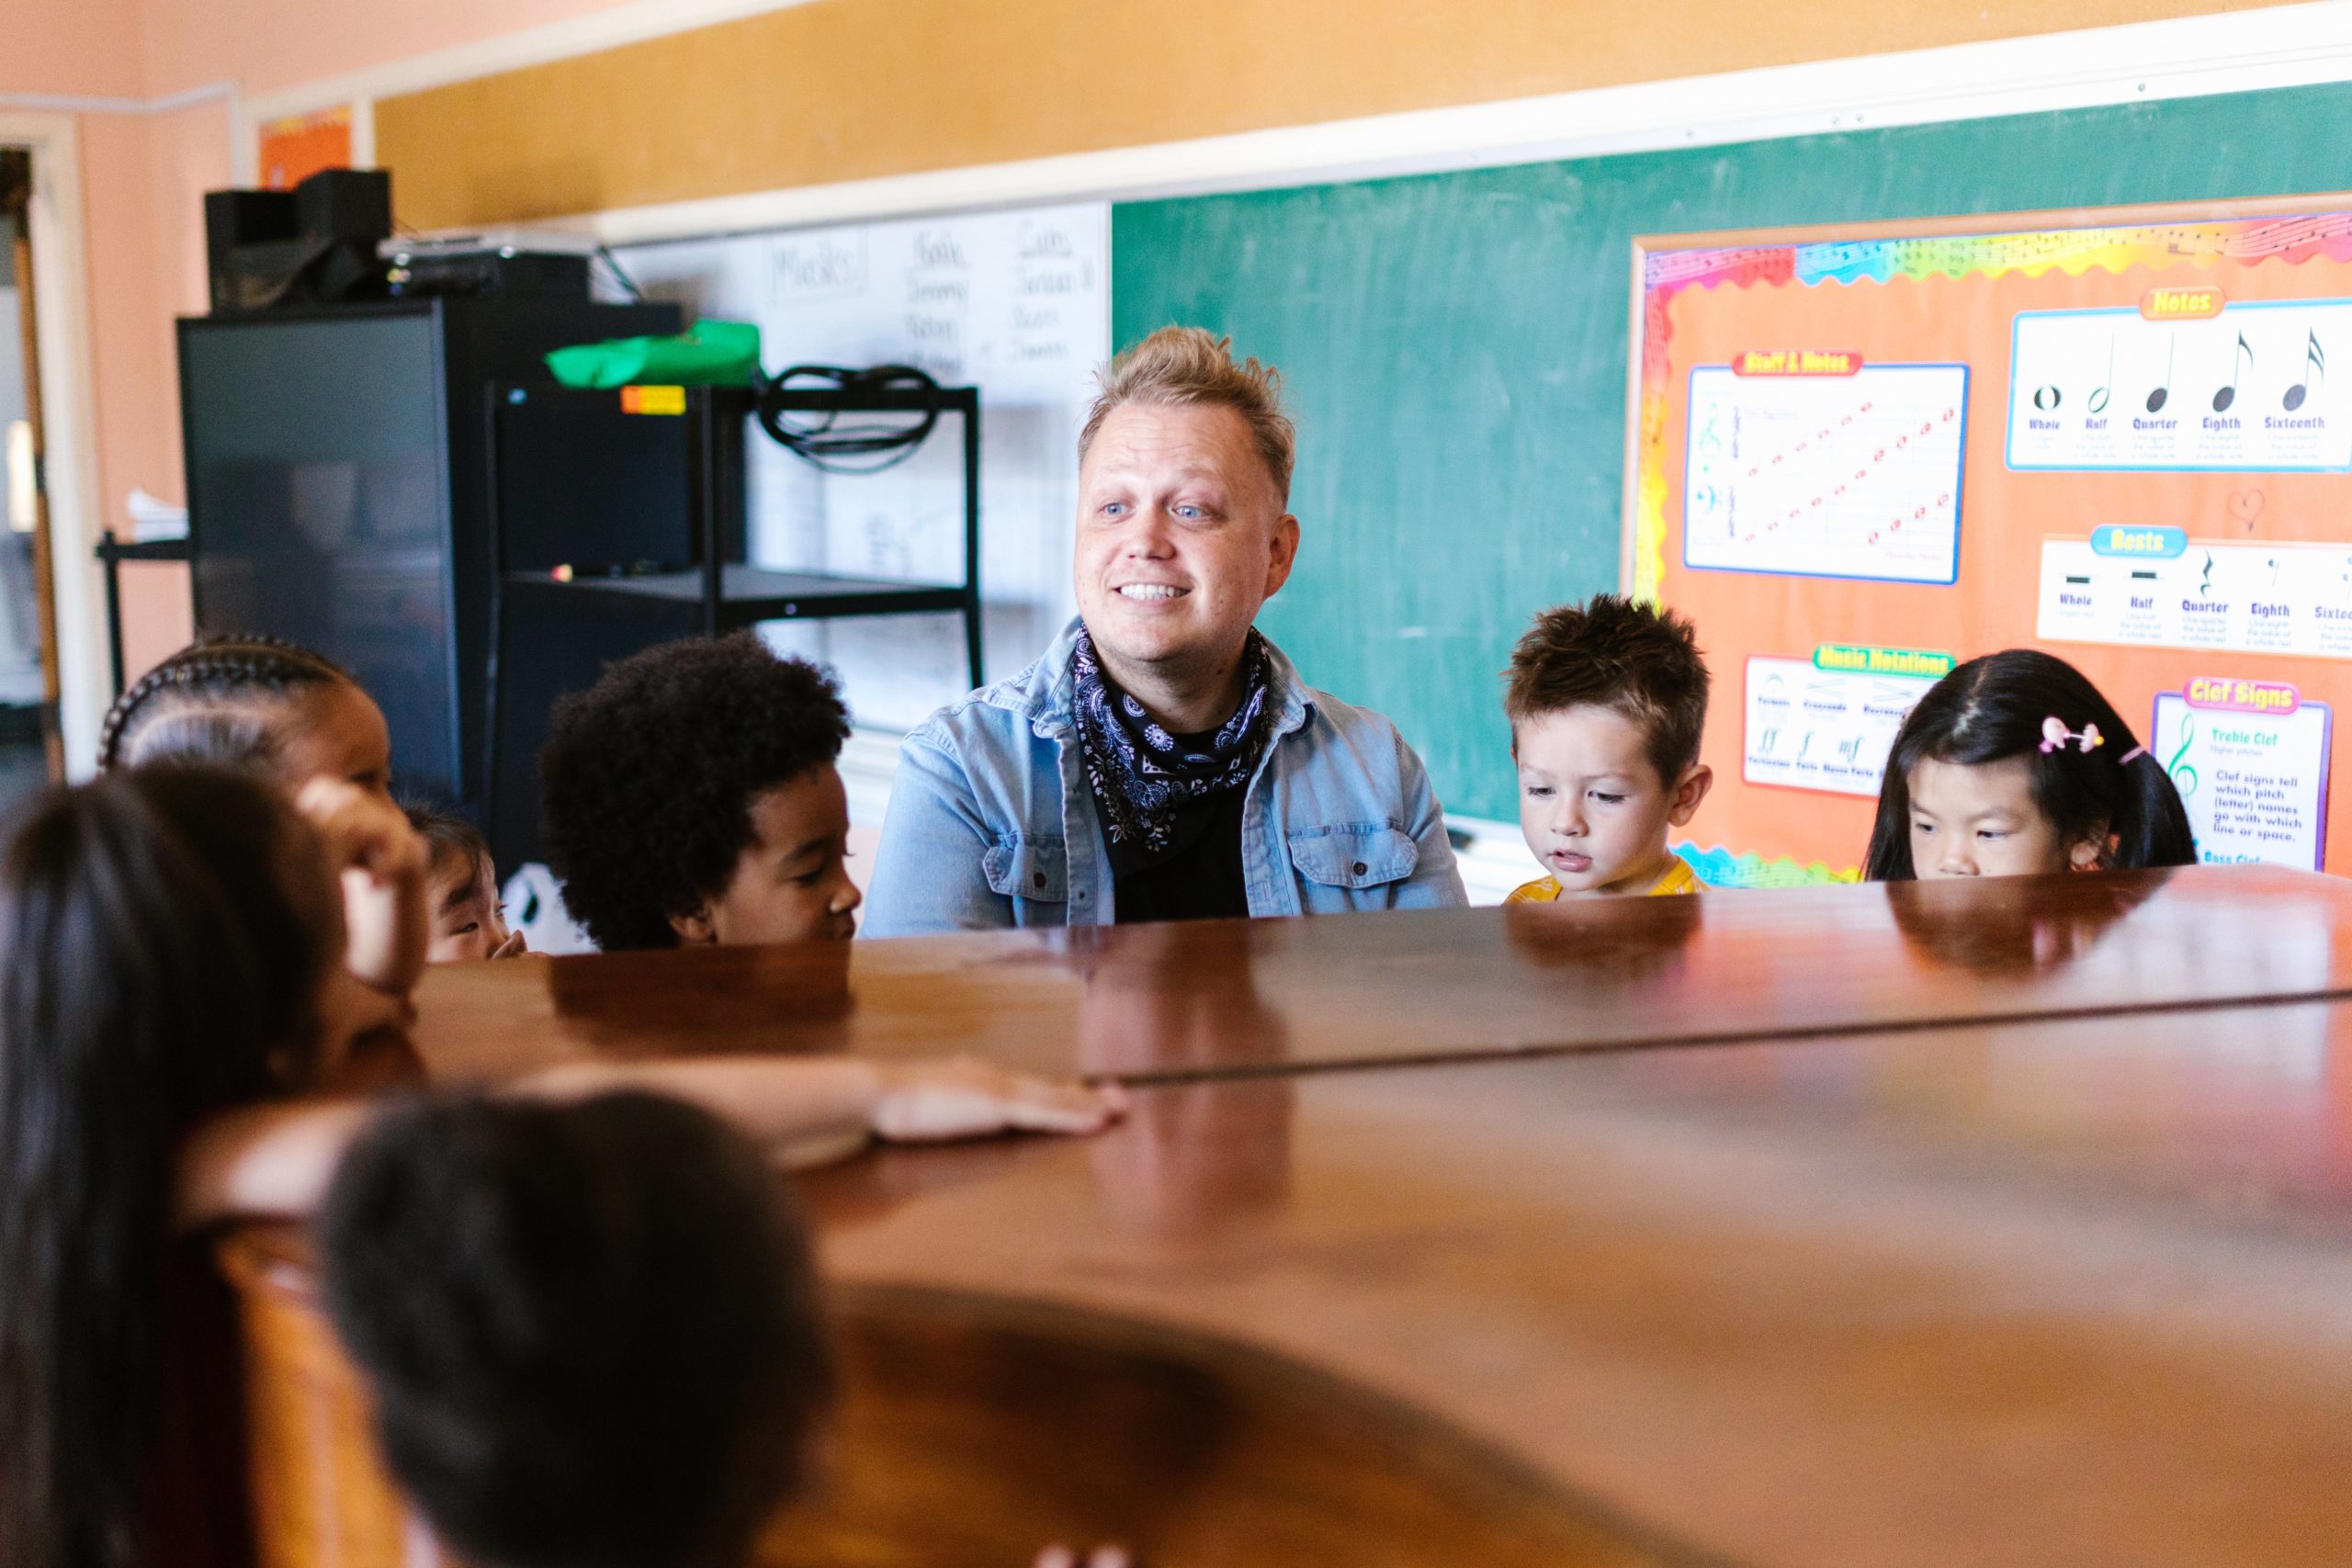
[[538, 632, 858, 952]]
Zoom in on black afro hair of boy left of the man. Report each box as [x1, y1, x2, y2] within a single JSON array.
[[538, 632, 849, 952]]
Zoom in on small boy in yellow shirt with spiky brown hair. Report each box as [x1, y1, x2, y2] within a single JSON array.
[[1503, 592, 1714, 903]]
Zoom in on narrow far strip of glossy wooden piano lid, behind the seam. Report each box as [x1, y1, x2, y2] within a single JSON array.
[[419, 867, 2352, 1081]]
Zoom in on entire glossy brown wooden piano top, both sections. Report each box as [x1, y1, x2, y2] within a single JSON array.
[[385, 870, 2352, 1568]]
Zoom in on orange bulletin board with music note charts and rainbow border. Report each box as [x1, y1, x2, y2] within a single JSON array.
[[1628, 195, 2352, 884]]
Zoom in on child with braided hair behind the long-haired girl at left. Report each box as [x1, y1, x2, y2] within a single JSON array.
[[99, 635, 430, 1013]]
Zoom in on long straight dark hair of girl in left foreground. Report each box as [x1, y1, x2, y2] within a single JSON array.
[[0, 764, 334, 1568]]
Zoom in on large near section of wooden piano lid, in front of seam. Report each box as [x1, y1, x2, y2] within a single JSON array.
[[780, 1004, 2352, 1568]]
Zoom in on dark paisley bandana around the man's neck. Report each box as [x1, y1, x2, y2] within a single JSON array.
[[1070, 627, 1275, 853]]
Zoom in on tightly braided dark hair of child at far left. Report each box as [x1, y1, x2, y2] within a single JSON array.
[[99, 632, 357, 773]]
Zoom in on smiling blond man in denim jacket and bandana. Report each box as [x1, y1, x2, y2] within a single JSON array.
[[865, 327, 1465, 936]]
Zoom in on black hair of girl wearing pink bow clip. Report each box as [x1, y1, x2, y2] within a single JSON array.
[[1863, 649, 2197, 882]]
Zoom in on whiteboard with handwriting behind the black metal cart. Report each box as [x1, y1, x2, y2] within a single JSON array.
[[618, 202, 1110, 728]]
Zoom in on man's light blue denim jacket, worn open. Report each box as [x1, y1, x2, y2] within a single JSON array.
[[864, 621, 1467, 936]]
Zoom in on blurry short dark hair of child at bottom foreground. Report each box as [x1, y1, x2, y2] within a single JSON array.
[[318, 1093, 832, 1568]]
